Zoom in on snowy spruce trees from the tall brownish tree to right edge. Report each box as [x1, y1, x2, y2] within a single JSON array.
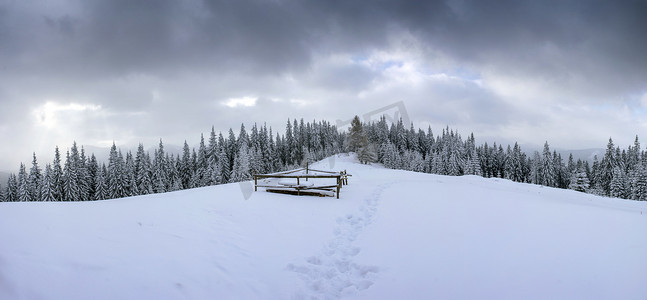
[[348, 116, 647, 201]]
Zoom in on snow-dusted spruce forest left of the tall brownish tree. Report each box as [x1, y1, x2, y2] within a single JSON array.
[[0, 119, 345, 202]]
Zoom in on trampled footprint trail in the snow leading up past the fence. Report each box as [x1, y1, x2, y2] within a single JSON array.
[[287, 183, 392, 299]]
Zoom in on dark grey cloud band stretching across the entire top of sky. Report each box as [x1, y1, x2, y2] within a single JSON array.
[[0, 0, 647, 94]]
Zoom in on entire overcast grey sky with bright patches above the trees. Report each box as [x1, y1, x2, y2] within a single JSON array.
[[0, 0, 647, 170]]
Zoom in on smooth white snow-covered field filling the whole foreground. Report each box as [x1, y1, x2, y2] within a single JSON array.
[[0, 155, 647, 299]]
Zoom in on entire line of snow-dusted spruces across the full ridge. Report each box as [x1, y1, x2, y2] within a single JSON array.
[[0, 116, 647, 201]]
